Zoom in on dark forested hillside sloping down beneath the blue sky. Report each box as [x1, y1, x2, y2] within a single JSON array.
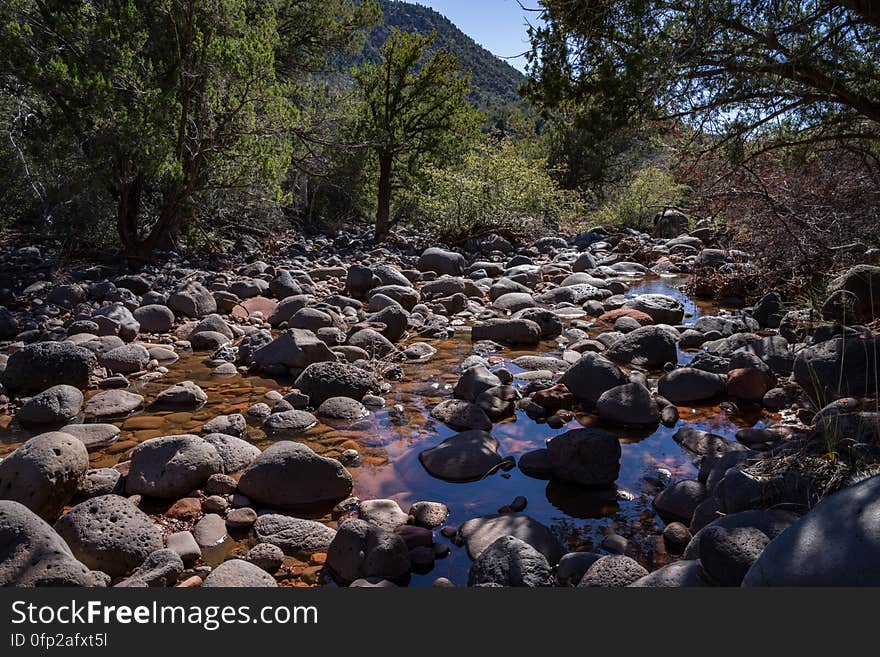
[[354, 0, 525, 107]]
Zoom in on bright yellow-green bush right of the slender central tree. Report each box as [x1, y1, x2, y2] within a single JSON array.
[[416, 138, 583, 243]]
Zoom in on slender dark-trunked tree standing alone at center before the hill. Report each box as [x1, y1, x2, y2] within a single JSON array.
[[354, 30, 479, 241]]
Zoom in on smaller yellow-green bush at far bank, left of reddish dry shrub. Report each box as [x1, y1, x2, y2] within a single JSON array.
[[589, 166, 688, 231]]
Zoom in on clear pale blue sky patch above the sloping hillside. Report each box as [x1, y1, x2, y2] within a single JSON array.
[[410, 0, 538, 71]]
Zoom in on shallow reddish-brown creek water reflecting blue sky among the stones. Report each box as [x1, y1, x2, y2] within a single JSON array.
[[0, 277, 763, 585]]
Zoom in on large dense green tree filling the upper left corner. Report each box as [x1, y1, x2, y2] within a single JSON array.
[[0, 0, 374, 258]]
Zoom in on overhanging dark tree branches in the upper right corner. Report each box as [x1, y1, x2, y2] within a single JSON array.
[[530, 0, 880, 160]]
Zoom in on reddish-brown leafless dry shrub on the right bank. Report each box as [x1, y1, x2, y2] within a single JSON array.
[[690, 144, 880, 302]]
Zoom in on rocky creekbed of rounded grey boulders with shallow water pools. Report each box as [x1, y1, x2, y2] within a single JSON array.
[[0, 224, 880, 587]]
